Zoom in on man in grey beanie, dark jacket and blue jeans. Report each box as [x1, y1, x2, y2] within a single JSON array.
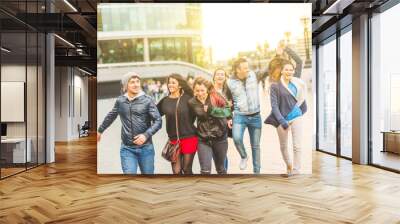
[[97, 73, 162, 174]]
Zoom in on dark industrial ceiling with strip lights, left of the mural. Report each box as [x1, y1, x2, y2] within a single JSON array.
[[0, 0, 97, 75]]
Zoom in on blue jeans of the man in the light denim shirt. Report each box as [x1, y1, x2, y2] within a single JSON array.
[[232, 114, 261, 173]]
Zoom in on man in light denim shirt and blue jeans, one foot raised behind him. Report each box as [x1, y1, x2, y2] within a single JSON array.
[[227, 58, 261, 174]]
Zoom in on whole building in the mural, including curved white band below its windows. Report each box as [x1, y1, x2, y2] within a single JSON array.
[[97, 3, 209, 92]]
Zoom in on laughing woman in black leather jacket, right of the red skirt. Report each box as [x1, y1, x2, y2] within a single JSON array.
[[189, 77, 231, 174]]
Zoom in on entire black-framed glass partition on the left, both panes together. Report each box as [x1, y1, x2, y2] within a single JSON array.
[[0, 1, 46, 178]]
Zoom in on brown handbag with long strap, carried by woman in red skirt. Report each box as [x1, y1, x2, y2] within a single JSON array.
[[161, 94, 183, 163]]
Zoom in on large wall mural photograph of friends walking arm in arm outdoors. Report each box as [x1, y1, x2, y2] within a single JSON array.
[[97, 3, 315, 176]]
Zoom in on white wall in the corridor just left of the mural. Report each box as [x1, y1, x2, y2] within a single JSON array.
[[55, 67, 88, 141]]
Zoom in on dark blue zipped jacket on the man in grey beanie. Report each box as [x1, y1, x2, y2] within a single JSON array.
[[98, 94, 162, 147]]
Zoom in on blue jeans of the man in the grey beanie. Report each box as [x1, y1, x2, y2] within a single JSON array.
[[120, 144, 154, 174]]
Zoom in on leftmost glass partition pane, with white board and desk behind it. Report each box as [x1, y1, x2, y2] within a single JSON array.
[[0, 32, 27, 178]]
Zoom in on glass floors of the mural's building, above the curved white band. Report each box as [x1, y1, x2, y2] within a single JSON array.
[[97, 4, 205, 66]]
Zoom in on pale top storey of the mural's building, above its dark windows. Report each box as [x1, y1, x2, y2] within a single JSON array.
[[97, 4, 201, 32]]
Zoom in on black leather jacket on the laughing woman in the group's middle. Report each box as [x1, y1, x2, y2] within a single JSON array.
[[189, 97, 228, 141]]
